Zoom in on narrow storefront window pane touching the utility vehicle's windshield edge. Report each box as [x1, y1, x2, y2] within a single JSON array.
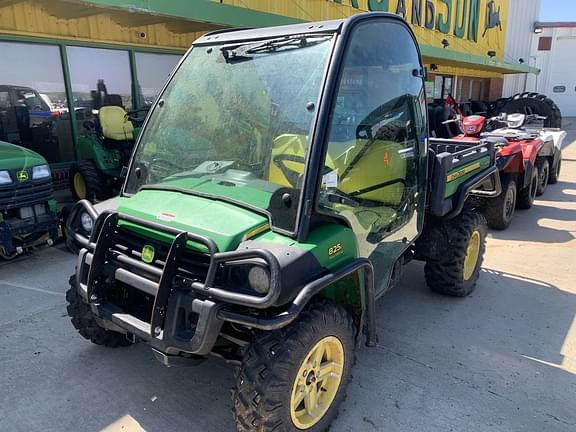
[[135, 53, 181, 108]]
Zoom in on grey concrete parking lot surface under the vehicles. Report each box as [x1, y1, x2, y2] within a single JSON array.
[[0, 121, 576, 432]]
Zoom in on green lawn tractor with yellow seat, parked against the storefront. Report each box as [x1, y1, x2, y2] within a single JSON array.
[[69, 87, 148, 202]]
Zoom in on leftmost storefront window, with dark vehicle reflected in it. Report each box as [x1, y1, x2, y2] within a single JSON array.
[[0, 42, 74, 163]]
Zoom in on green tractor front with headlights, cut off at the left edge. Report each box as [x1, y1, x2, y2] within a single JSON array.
[[0, 141, 60, 259]]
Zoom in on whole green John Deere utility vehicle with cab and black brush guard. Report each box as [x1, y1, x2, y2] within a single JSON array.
[[67, 13, 500, 431]]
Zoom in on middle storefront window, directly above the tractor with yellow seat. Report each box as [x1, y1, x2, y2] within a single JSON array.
[[66, 47, 132, 111]]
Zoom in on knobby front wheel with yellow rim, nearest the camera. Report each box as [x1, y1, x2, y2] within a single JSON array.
[[232, 300, 356, 432]]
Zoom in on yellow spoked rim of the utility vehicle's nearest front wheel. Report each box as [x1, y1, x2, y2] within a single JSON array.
[[290, 336, 345, 429]]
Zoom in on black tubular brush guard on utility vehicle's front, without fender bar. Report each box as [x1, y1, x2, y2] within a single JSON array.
[[77, 209, 280, 356]]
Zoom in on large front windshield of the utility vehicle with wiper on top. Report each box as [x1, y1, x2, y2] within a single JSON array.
[[125, 34, 333, 231]]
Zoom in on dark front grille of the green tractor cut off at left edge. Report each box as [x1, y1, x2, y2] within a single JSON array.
[[0, 169, 54, 210]]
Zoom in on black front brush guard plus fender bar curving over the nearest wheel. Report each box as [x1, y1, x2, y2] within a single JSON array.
[[72, 203, 375, 364]]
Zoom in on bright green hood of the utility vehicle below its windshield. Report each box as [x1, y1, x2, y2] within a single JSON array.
[[118, 190, 268, 252]]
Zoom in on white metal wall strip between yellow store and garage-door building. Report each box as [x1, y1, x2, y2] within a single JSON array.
[[502, 0, 540, 97]]
